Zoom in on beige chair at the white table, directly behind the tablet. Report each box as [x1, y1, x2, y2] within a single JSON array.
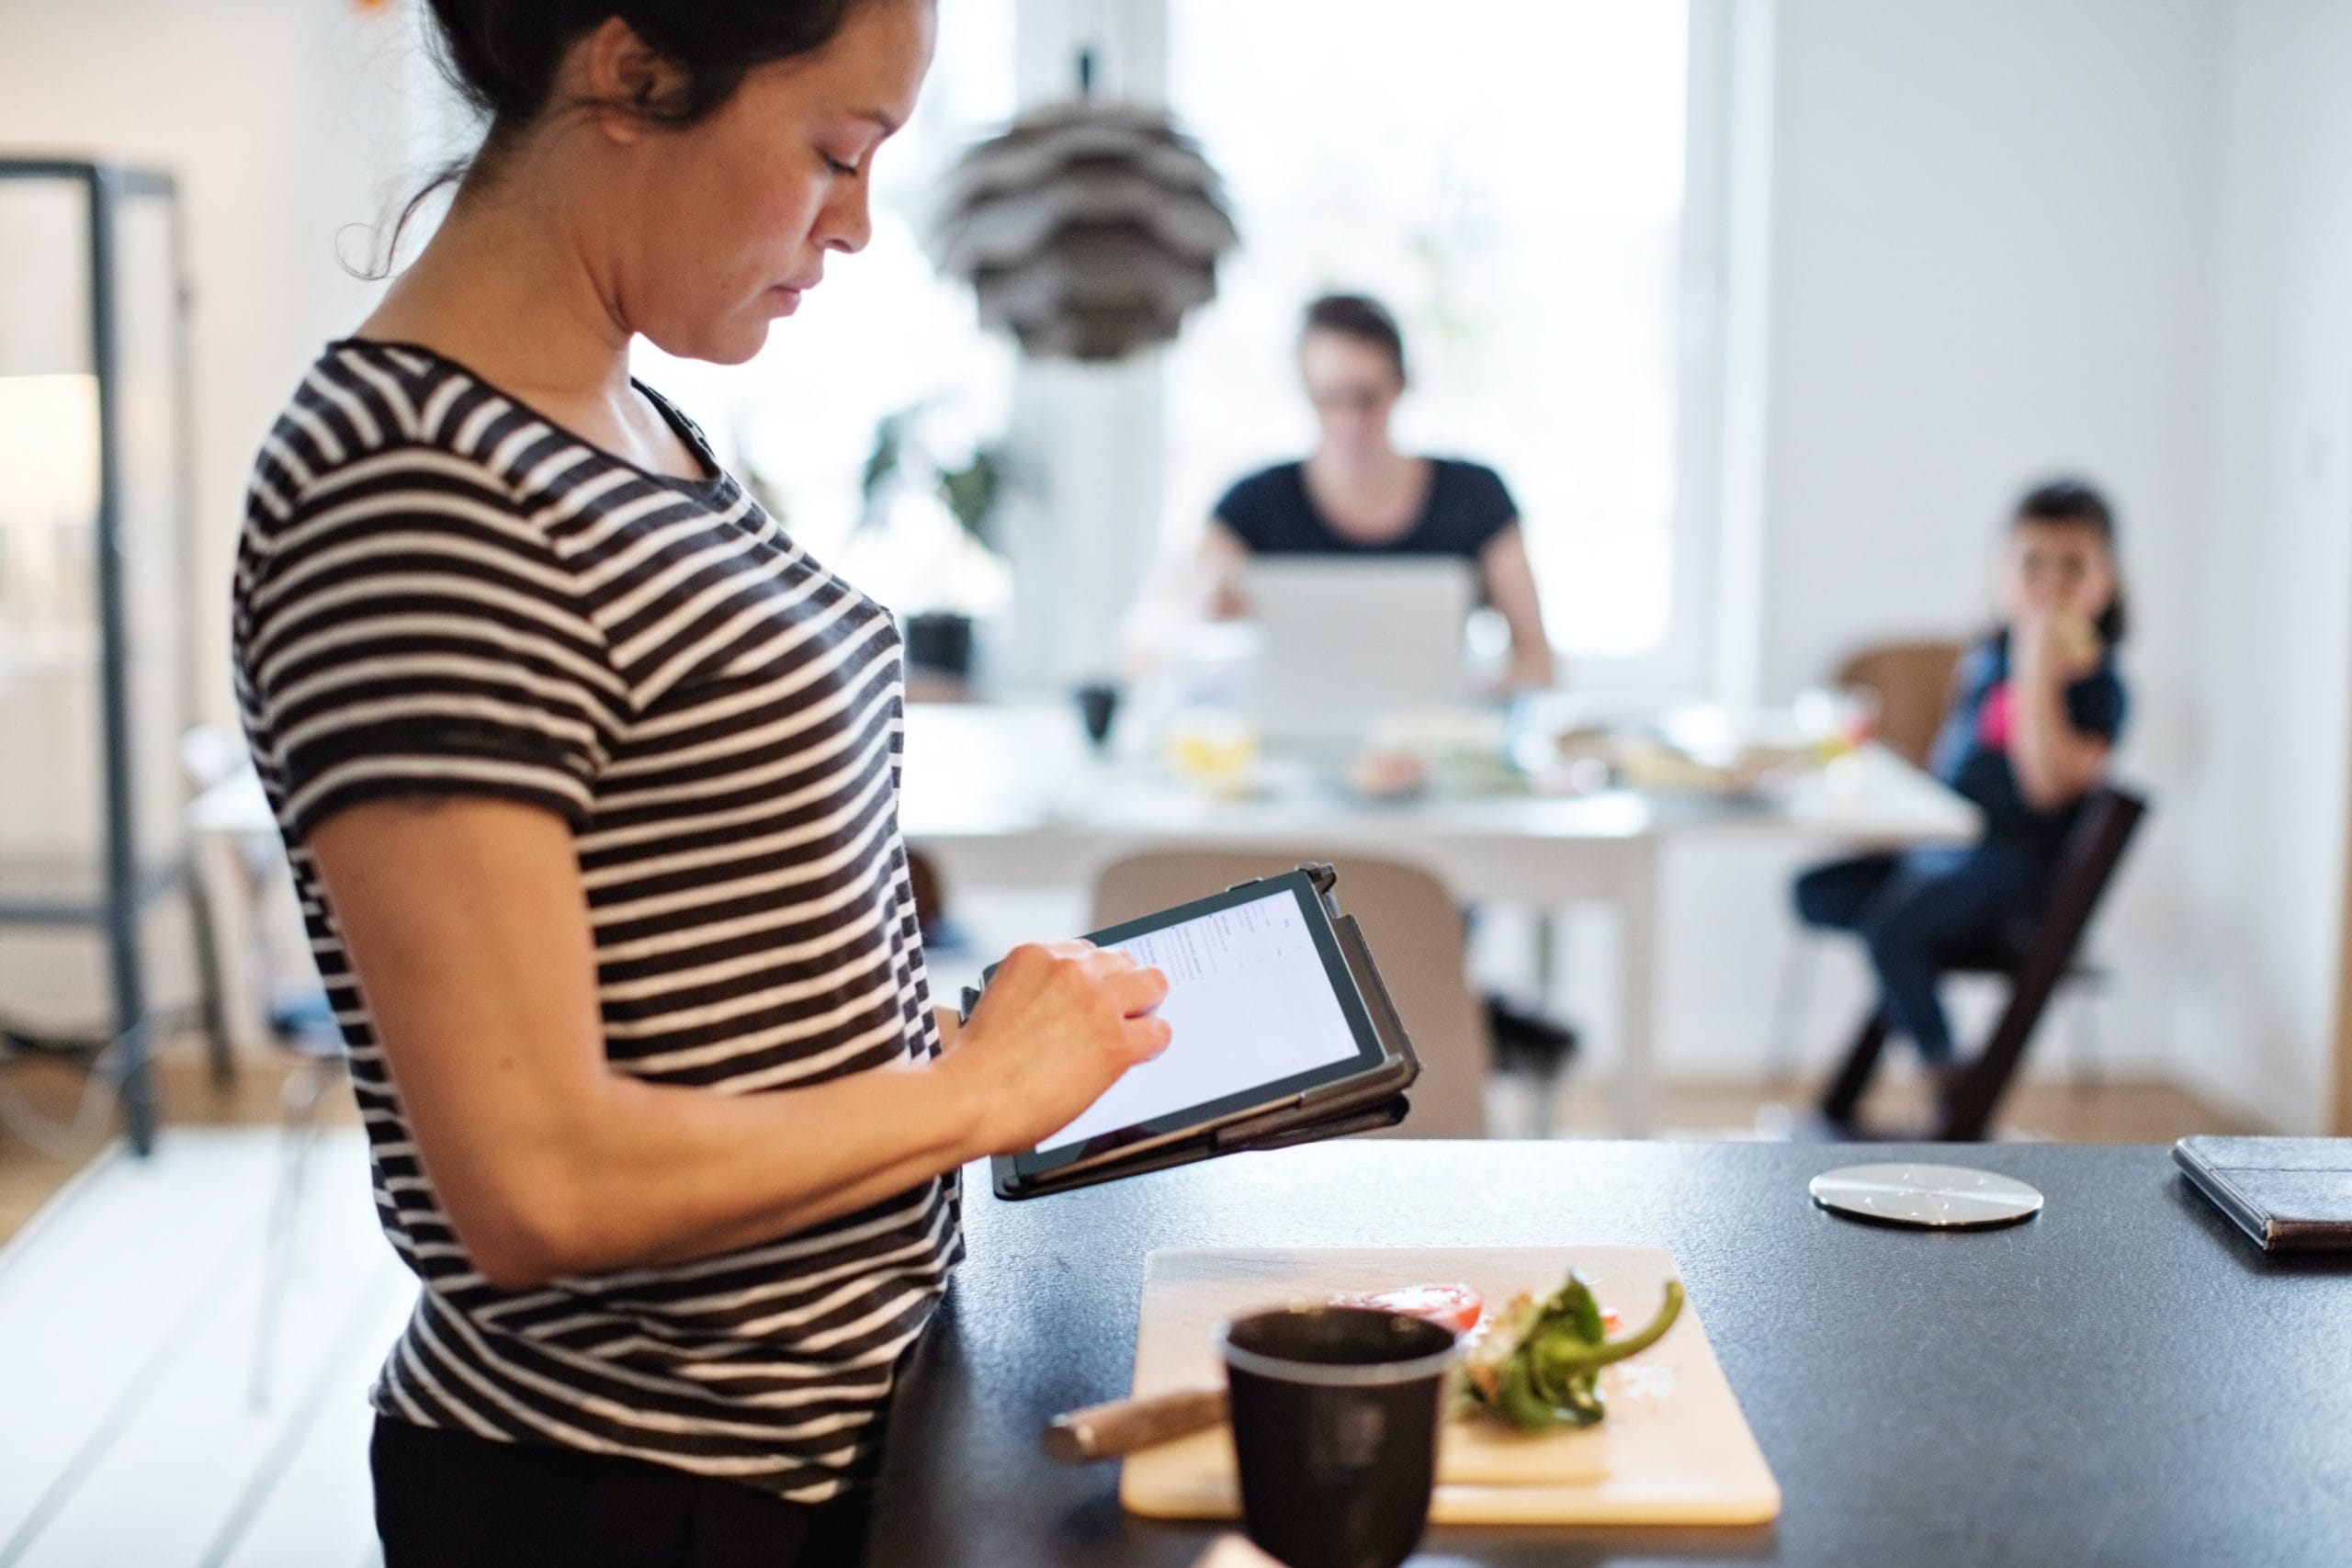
[[1091, 849, 1488, 1138]]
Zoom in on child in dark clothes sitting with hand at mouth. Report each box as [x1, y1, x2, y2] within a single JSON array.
[[1797, 479, 2124, 1093]]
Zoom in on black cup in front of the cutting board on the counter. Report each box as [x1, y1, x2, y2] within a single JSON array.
[[1216, 1307, 1453, 1568]]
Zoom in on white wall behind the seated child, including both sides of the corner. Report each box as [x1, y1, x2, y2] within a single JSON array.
[[1663, 0, 2352, 1131]]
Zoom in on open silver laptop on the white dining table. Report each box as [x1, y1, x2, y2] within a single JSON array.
[[1242, 555, 1477, 740]]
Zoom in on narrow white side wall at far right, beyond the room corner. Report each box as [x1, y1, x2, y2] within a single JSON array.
[[2176, 0, 2352, 1131]]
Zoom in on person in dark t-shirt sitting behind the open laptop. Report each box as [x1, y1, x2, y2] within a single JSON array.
[[1202, 294, 1553, 689]]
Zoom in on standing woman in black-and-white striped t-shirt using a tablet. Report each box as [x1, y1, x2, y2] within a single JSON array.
[[235, 0, 1167, 1568]]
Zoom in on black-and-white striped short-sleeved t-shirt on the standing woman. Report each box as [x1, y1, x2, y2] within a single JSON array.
[[221, 341, 962, 1502]]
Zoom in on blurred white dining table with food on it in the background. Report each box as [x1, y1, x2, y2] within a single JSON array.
[[900, 701, 1981, 1138]]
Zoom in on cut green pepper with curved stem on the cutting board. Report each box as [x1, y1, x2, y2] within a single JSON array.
[[1463, 1272, 1681, 1432]]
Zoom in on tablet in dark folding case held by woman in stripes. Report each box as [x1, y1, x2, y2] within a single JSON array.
[[983, 870, 1416, 1187]]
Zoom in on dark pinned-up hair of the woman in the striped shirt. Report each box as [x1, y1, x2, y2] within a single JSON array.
[[377, 0, 864, 275]]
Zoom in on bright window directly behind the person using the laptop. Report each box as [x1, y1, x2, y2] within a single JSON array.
[[1167, 0, 1702, 670]]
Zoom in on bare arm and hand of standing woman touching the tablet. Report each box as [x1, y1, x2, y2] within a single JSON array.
[[311, 797, 1167, 1288]]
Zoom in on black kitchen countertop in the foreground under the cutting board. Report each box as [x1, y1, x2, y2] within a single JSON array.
[[865, 1140, 2352, 1568]]
